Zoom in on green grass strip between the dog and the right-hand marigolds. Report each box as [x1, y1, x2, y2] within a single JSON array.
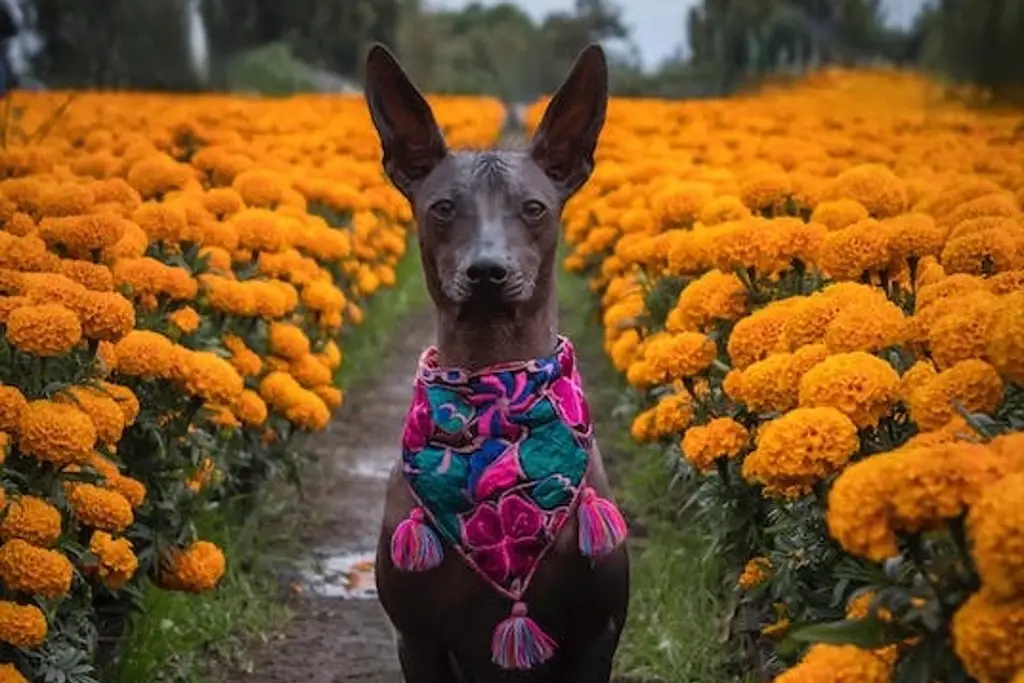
[[559, 259, 741, 683]]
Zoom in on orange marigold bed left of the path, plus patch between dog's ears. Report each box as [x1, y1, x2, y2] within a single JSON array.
[[0, 93, 501, 683]]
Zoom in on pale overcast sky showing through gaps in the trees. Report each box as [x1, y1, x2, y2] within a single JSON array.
[[429, 0, 925, 67]]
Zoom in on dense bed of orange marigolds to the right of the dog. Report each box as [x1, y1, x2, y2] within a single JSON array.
[[528, 72, 1024, 683]]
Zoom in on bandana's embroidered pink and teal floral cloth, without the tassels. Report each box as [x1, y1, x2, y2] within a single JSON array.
[[402, 338, 593, 597]]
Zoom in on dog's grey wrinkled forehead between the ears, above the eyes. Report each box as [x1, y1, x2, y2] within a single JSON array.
[[418, 151, 558, 204]]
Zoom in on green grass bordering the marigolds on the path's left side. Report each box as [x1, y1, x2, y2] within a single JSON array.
[[113, 237, 427, 683]]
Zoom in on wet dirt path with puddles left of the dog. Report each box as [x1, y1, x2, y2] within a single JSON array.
[[225, 311, 434, 683]]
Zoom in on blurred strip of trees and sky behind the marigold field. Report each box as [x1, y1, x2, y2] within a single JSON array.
[[0, 0, 1024, 104]]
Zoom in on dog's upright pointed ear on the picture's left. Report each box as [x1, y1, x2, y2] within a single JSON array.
[[366, 43, 447, 199]]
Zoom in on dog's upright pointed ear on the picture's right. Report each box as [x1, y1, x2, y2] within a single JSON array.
[[530, 45, 608, 197]]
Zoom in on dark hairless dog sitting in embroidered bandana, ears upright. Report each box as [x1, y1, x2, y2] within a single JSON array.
[[366, 45, 629, 683]]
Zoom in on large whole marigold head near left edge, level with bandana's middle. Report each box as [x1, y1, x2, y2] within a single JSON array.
[[17, 400, 96, 466]]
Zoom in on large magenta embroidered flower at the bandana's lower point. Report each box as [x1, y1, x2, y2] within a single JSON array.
[[462, 494, 544, 585]]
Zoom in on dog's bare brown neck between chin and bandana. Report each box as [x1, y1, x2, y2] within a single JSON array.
[[437, 289, 558, 371]]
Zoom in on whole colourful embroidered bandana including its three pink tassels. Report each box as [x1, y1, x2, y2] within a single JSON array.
[[391, 337, 627, 670]]
